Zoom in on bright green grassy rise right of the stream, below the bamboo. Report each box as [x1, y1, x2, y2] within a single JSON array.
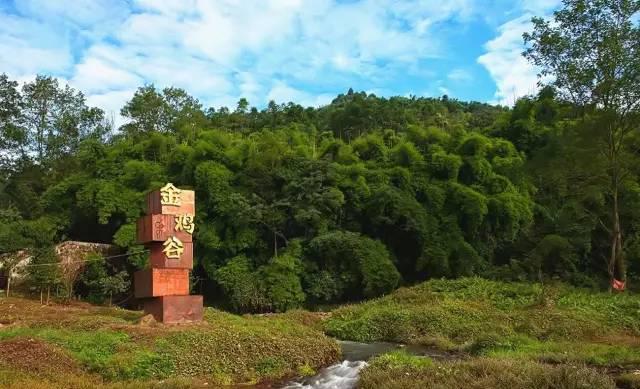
[[325, 278, 640, 345]]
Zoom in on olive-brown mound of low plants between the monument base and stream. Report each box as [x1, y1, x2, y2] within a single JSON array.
[[151, 309, 339, 383]]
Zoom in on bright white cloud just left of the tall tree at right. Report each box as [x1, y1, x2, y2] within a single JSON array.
[[478, 15, 538, 105]]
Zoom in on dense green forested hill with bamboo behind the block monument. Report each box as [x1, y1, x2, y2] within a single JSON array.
[[0, 76, 640, 311]]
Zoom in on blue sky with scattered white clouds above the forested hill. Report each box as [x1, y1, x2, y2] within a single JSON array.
[[0, 0, 559, 119]]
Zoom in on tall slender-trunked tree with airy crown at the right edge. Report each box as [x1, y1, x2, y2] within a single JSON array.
[[524, 0, 640, 281]]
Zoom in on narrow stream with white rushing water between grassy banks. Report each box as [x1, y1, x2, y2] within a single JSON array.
[[282, 341, 447, 389]]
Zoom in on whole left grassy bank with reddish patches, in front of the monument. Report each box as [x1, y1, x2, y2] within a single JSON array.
[[0, 298, 339, 388]]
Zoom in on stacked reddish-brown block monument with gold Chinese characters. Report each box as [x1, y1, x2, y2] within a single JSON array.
[[134, 183, 203, 323]]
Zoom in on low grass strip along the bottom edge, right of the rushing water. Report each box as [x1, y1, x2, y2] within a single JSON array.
[[359, 353, 615, 389]]
